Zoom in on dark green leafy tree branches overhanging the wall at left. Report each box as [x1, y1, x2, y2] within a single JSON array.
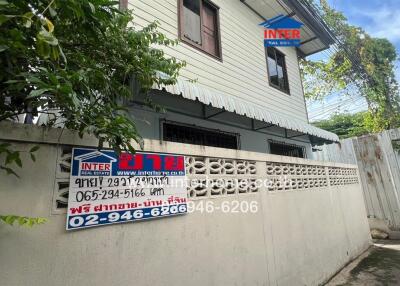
[[0, 0, 185, 154]]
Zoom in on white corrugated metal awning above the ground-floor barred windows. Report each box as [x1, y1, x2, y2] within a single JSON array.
[[157, 80, 339, 142]]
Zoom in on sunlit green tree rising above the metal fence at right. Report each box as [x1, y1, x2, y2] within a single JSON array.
[[301, 0, 400, 132]]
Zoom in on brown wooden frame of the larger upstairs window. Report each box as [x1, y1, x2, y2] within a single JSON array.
[[178, 0, 222, 62]]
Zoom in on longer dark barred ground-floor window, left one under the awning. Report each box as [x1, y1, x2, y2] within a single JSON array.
[[162, 122, 239, 149]]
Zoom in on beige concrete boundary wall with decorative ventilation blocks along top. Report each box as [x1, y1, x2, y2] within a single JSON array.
[[0, 123, 370, 286]]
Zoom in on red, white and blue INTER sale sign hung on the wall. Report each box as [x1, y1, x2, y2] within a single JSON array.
[[67, 148, 187, 230]]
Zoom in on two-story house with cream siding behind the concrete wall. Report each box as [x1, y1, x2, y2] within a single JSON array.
[[121, 0, 338, 158]]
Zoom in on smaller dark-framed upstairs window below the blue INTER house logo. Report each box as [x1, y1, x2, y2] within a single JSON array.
[[266, 47, 289, 93]]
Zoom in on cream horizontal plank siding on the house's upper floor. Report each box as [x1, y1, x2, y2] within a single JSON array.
[[129, 0, 307, 122]]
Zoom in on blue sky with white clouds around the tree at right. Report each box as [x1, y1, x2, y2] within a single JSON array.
[[307, 0, 400, 121]]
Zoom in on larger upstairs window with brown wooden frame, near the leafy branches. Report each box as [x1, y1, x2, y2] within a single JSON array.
[[178, 0, 221, 59]]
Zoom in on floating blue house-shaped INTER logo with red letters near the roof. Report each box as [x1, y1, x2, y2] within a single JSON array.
[[259, 15, 303, 47]]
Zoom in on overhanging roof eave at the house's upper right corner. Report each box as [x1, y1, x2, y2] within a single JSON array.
[[240, 0, 335, 57]]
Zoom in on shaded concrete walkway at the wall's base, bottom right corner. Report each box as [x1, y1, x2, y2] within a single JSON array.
[[326, 240, 400, 286]]
